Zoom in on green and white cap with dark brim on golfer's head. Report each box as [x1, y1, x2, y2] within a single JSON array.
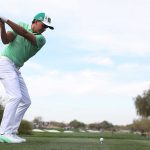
[[34, 13, 54, 30]]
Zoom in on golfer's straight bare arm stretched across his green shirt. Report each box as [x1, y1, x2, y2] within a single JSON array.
[[6, 20, 36, 45]]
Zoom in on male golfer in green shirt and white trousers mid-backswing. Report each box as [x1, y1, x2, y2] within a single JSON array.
[[0, 13, 54, 143]]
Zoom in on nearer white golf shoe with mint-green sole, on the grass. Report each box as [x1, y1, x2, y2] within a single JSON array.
[[0, 134, 23, 143]]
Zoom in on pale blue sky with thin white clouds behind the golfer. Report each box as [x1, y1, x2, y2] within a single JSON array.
[[0, 0, 150, 125]]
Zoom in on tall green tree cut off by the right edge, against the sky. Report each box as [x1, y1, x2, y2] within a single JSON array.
[[135, 89, 150, 118]]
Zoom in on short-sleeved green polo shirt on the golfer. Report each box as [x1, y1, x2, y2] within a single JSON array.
[[0, 23, 46, 67]]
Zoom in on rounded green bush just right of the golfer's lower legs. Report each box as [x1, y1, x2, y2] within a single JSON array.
[[19, 120, 32, 134]]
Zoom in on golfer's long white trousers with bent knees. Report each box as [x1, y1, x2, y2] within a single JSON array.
[[0, 56, 31, 134]]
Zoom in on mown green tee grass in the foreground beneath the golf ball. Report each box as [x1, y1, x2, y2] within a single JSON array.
[[0, 136, 150, 150]]
